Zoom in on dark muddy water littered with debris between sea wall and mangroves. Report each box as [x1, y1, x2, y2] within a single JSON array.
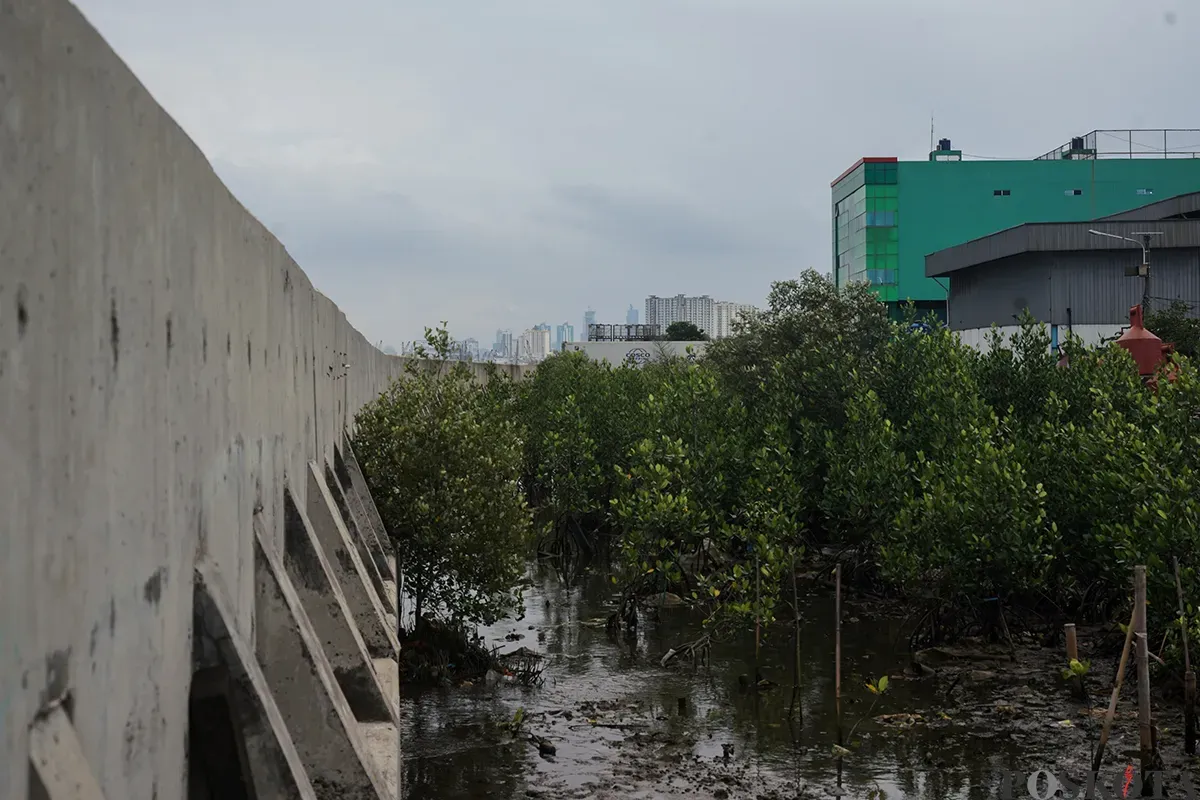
[[402, 563, 1135, 800]]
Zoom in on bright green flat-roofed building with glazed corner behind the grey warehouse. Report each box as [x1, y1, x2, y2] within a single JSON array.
[[832, 130, 1200, 319]]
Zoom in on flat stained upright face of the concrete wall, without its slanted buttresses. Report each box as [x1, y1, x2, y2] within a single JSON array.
[[0, 0, 528, 800]]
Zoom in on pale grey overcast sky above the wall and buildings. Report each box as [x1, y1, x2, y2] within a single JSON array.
[[79, 0, 1200, 347]]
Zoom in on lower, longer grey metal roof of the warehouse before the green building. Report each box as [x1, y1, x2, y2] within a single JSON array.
[[925, 219, 1200, 278]]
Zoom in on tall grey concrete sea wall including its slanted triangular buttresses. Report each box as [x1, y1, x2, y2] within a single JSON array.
[[0, 0, 525, 800]]
